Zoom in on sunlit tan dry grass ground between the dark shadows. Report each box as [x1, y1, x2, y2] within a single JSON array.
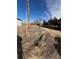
[[17, 25, 60, 59]]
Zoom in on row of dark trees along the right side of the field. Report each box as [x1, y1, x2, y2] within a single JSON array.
[[43, 17, 61, 30]]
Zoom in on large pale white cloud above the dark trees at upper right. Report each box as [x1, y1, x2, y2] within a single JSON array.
[[44, 0, 61, 18]]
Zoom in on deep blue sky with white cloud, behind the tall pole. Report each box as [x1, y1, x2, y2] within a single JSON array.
[[17, 0, 61, 22]]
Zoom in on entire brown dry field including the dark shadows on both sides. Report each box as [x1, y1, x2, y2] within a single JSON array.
[[17, 25, 61, 59]]
